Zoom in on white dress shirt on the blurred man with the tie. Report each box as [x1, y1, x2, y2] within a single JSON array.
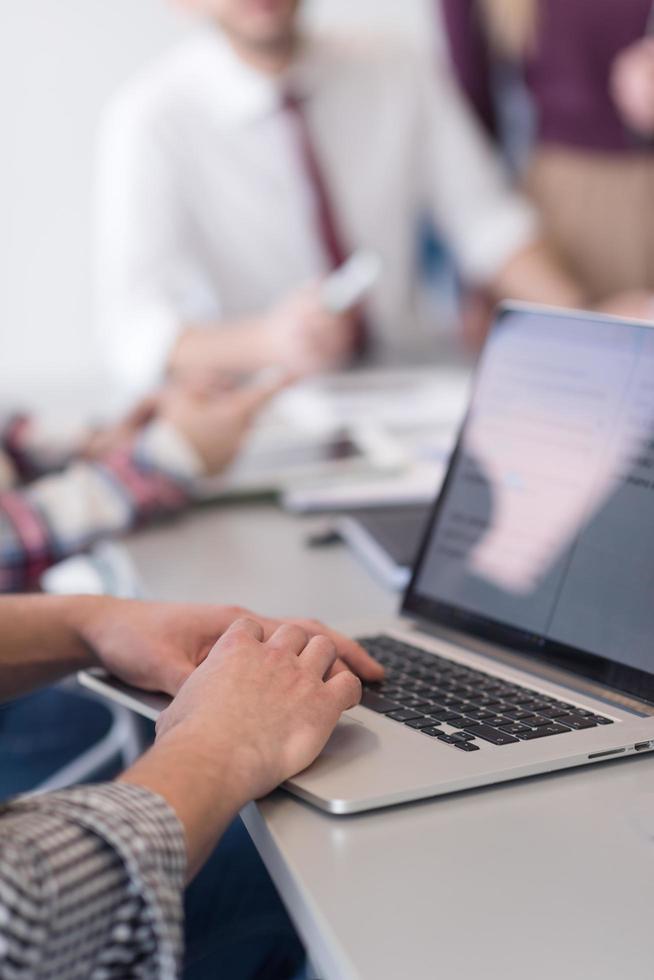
[[99, 29, 537, 389]]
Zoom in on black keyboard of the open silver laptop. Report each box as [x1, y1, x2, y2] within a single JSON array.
[[359, 636, 613, 752]]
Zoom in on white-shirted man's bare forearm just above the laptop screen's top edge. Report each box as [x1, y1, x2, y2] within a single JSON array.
[[491, 242, 585, 308]]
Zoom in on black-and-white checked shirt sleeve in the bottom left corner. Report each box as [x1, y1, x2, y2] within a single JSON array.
[[0, 783, 186, 980]]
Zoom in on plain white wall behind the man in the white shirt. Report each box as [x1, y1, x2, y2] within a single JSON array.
[[0, 0, 440, 404]]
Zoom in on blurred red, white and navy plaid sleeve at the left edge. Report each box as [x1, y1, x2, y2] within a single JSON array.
[[0, 420, 202, 592]]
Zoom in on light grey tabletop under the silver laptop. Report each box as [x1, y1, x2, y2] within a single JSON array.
[[129, 503, 654, 980]]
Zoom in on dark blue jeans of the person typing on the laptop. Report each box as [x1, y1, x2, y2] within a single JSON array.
[[0, 688, 304, 980]]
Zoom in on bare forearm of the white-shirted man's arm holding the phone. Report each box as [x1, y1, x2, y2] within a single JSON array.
[[169, 317, 276, 378]]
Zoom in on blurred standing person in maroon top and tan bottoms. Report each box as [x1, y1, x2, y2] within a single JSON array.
[[441, 0, 654, 318]]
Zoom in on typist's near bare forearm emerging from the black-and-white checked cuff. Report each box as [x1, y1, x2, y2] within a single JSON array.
[[120, 727, 249, 880]]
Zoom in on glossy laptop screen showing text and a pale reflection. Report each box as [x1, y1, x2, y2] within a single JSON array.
[[404, 307, 654, 701]]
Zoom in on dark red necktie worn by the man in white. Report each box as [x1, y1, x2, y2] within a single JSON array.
[[282, 92, 370, 357]]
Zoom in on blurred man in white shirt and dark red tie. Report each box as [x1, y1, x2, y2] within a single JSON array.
[[100, 0, 600, 390]]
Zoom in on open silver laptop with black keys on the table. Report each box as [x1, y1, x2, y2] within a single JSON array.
[[80, 305, 654, 814]]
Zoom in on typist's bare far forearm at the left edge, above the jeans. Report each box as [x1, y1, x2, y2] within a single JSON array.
[[0, 596, 109, 700]]
